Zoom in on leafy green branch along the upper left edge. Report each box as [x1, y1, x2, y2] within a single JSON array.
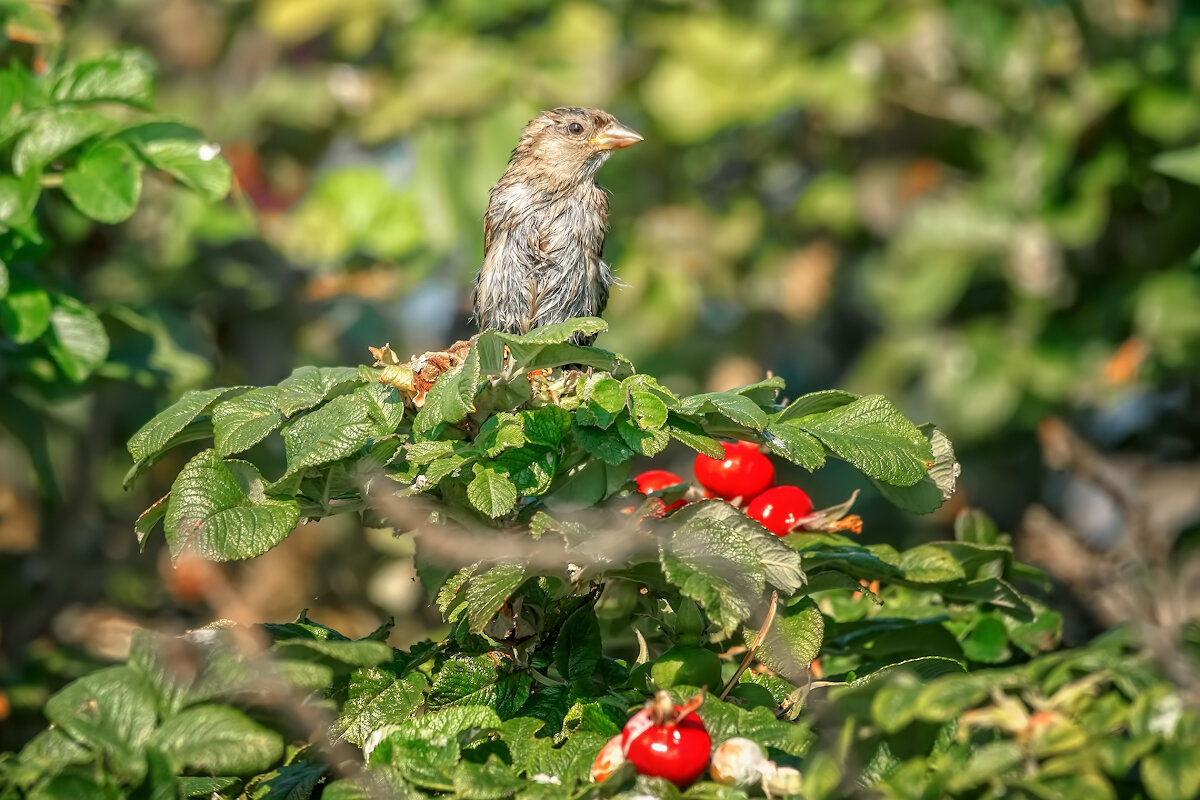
[[0, 20, 232, 494]]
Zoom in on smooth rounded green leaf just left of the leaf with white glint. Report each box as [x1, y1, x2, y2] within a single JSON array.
[[62, 142, 142, 224]]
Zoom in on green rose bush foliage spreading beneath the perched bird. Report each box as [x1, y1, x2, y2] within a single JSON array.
[[9, 319, 1200, 798]]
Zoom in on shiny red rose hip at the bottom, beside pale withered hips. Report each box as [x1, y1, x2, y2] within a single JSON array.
[[620, 693, 713, 787]]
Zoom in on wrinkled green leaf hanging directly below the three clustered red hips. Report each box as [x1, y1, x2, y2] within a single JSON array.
[[659, 519, 766, 631]]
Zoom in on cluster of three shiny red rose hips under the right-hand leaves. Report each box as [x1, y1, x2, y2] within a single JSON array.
[[634, 441, 812, 536]]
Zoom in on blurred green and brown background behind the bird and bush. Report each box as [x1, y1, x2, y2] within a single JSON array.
[[0, 0, 1200, 746]]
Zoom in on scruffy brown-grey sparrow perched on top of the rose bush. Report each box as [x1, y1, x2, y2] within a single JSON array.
[[473, 107, 642, 345]]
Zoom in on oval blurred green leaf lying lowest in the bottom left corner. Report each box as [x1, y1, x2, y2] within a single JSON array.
[[152, 705, 283, 775]]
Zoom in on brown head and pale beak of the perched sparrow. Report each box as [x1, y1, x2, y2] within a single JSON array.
[[510, 108, 642, 187]]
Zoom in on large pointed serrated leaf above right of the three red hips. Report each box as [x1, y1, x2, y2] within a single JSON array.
[[797, 395, 934, 486]]
